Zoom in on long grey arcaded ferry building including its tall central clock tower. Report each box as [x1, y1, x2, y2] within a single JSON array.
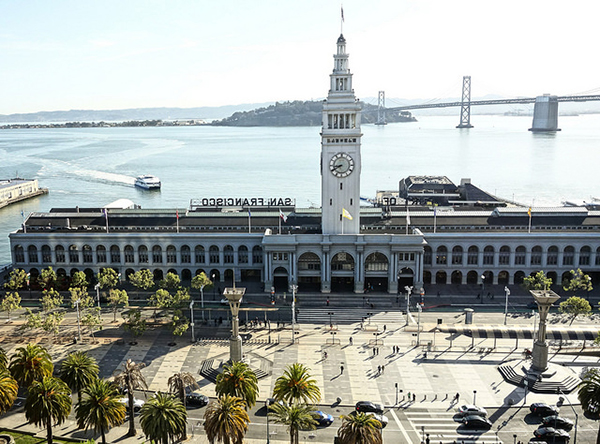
[[10, 35, 600, 294]]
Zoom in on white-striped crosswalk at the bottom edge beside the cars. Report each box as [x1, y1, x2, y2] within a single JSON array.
[[404, 409, 502, 444]]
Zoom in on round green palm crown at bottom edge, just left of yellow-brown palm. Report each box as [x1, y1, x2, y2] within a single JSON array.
[[140, 393, 187, 444]]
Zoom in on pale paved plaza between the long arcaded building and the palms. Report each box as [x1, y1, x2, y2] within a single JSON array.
[[0, 298, 600, 444]]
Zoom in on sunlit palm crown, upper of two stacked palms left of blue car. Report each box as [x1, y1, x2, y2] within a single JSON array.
[[273, 362, 321, 404]]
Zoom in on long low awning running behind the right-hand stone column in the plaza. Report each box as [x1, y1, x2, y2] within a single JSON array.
[[437, 325, 598, 341]]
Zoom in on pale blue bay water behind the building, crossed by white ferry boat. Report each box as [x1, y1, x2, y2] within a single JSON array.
[[0, 114, 600, 265]]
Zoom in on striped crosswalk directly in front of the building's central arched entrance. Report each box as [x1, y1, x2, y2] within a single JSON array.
[[296, 307, 406, 328]]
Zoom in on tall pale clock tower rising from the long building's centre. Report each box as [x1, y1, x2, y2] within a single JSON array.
[[321, 34, 362, 234]]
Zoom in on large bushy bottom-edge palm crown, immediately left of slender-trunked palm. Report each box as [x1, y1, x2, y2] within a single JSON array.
[[75, 379, 126, 444]]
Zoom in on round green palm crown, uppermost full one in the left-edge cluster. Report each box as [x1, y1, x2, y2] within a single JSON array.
[[8, 344, 54, 389]]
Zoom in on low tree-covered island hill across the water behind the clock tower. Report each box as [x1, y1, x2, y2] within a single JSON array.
[[211, 100, 416, 126]]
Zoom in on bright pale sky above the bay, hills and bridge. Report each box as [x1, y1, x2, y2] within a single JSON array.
[[0, 0, 600, 114]]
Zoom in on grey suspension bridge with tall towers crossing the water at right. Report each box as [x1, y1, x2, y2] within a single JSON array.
[[376, 76, 600, 132]]
